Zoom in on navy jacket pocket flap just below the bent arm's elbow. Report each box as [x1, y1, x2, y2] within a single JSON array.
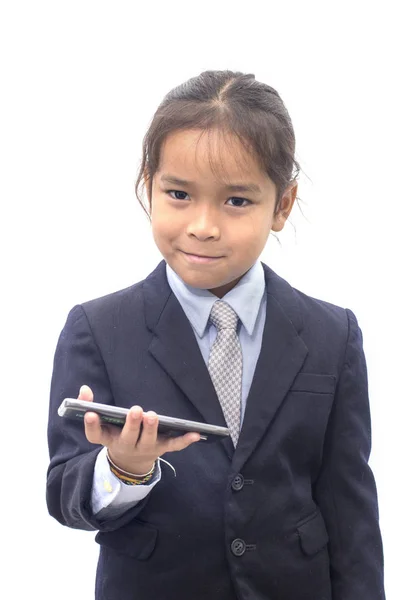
[[95, 521, 158, 560]]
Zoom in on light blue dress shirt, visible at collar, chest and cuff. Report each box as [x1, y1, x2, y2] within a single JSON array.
[[92, 261, 267, 518]]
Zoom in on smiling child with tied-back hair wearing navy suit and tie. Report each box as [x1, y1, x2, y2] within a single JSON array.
[[47, 71, 385, 600]]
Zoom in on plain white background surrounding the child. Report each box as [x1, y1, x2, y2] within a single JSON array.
[[0, 0, 400, 600]]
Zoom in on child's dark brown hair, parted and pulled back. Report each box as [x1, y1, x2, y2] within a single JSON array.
[[135, 70, 300, 215]]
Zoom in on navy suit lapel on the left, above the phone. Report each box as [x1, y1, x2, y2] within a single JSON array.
[[143, 261, 234, 457]]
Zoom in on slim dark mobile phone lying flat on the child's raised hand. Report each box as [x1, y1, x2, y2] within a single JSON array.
[[58, 398, 230, 442]]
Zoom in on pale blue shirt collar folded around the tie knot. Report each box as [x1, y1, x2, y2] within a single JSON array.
[[166, 261, 265, 338]]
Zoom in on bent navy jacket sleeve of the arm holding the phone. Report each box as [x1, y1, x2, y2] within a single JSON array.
[[46, 305, 153, 531]]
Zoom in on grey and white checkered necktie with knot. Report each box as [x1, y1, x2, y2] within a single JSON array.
[[208, 300, 242, 447]]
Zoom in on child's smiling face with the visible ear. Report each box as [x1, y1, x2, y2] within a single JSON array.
[[147, 130, 297, 298]]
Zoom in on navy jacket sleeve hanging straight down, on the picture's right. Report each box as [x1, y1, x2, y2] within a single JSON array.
[[314, 310, 385, 600]]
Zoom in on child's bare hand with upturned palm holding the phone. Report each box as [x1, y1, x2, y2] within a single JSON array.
[[69, 385, 208, 475]]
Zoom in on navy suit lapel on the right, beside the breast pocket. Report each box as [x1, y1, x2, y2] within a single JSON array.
[[233, 264, 308, 470]]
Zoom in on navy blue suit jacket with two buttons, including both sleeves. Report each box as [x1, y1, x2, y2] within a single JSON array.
[[47, 261, 385, 600]]
